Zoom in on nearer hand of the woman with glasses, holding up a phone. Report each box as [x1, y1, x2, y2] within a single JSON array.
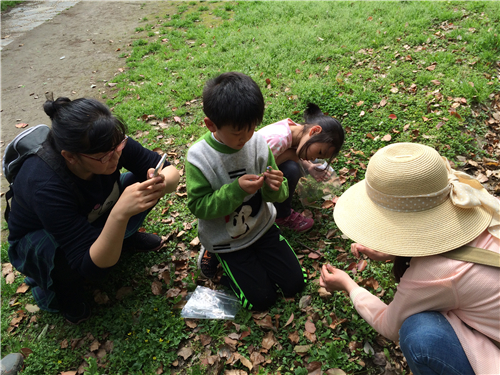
[[112, 176, 164, 220]]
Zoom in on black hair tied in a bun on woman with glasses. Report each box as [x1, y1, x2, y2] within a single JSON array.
[[43, 97, 127, 154]]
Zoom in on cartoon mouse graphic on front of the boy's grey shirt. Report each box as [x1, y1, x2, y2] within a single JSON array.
[[225, 192, 262, 240]]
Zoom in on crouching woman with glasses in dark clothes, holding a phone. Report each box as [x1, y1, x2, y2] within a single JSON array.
[[8, 98, 180, 323]]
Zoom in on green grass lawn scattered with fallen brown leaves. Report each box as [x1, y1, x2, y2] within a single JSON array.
[[1, 1, 500, 374]]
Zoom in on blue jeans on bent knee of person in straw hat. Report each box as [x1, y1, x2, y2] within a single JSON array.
[[399, 311, 474, 375]]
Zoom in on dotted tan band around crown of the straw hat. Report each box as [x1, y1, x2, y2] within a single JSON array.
[[365, 179, 451, 212]]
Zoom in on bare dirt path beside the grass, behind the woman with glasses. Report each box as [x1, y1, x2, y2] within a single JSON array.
[[0, 1, 175, 194]]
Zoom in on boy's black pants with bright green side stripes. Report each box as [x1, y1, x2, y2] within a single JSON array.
[[217, 225, 307, 311]]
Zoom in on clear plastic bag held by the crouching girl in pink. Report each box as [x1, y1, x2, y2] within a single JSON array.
[[296, 160, 342, 208]]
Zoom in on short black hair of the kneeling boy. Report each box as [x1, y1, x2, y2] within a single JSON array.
[[203, 72, 264, 130]]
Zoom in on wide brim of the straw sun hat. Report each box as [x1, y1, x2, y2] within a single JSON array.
[[333, 180, 492, 257]]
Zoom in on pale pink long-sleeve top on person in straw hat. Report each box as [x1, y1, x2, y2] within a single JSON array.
[[350, 231, 500, 375]]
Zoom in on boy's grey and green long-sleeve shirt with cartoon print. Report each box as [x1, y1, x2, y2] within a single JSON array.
[[186, 132, 288, 252]]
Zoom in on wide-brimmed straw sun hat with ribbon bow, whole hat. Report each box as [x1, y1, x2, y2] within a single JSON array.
[[334, 143, 498, 256]]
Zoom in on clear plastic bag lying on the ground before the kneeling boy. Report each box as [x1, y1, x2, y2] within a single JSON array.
[[181, 286, 241, 319]]
